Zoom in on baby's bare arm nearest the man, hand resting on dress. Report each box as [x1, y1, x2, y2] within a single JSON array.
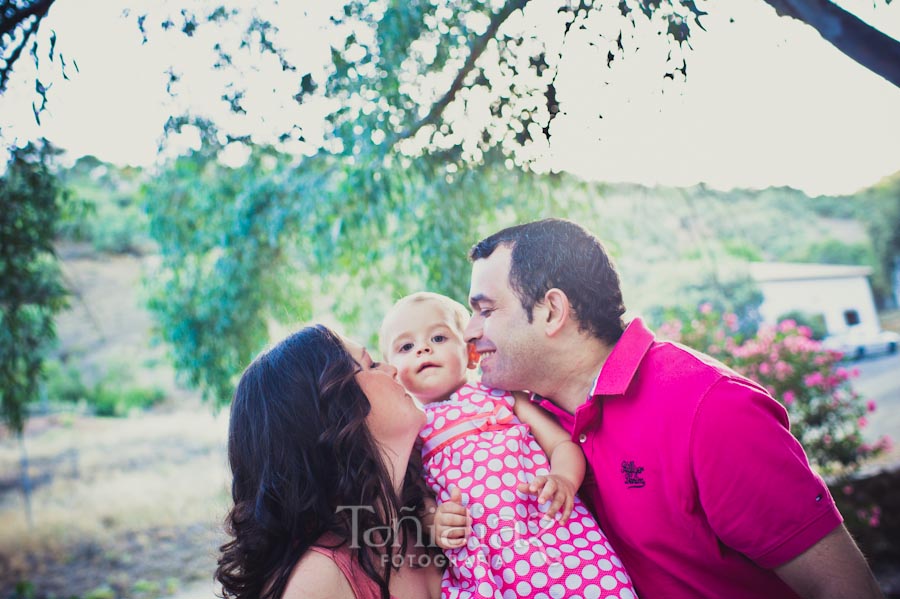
[[513, 393, 585, 524]]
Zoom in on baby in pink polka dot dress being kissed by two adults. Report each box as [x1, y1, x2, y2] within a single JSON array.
[[381, 292, 636, 599]]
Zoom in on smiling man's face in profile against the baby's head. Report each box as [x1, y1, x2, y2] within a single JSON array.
[[465, 246, 542, 390]]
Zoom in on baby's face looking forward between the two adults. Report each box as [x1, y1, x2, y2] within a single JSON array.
[[384, 301, 468, 403]]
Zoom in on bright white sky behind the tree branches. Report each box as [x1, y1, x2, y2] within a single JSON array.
[[0, 0, 900, 195]]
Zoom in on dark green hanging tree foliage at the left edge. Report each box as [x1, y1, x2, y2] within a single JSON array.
[[0, 139, 66, 433]]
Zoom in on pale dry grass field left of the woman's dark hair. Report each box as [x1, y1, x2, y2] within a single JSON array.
[[0, 407, 229, 597]]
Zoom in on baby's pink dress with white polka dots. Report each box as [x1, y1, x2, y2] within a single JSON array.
[[420, 383, 636, 599]]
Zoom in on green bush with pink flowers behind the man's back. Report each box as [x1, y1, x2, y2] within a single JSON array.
[[659, 304, 890, 478]]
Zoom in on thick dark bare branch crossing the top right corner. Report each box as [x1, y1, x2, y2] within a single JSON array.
[[765, 0, 900, 87]]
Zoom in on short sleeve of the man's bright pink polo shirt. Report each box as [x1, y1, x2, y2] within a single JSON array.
[[690, 377, 842, 569]]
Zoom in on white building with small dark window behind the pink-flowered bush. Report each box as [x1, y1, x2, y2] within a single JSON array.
[[750, 262, 881, 335]]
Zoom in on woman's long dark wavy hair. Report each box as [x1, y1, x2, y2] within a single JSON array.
[[216, 326, 425, 599]]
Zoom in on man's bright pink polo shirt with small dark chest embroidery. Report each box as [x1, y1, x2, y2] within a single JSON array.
[[534, 319, 842, 599]]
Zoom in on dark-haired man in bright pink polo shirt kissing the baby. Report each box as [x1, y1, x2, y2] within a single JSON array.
[[466, 219, 882, 599]]
